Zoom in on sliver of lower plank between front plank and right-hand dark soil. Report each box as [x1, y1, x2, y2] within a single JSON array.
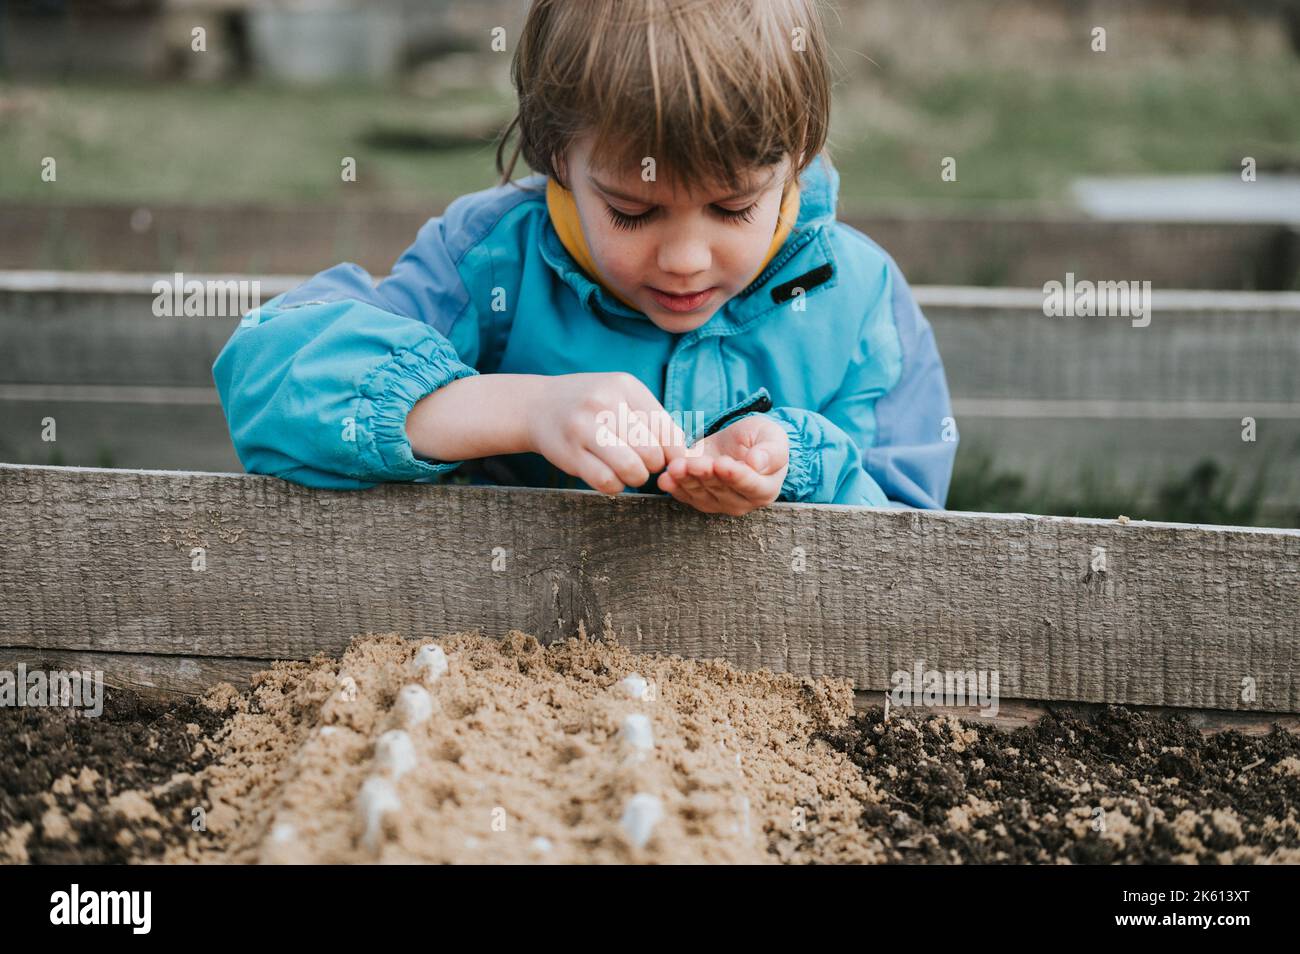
[[853, 690, 1300, 736]]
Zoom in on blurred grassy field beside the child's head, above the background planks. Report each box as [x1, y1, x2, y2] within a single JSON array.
[[0, 0, 1300, 208]]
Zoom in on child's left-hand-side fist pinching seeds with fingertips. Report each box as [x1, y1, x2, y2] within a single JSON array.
[[525, 372, 686, 494]]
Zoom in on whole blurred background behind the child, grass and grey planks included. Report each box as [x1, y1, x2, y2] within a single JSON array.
[[0, 0, 1300, 526]]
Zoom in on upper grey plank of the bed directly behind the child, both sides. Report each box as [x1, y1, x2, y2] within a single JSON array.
[[0, 273, 1300, 405]]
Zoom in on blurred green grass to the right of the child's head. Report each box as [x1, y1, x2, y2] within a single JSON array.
[[832, 58, 1300, 201]]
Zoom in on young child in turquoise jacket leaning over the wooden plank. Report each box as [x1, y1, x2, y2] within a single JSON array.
[[213, 0, 957, 516]]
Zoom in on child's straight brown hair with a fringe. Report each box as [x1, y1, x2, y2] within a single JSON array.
[[497, 0, 831, 197]]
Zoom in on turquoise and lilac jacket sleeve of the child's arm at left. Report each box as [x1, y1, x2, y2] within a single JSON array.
[[212, 196, 499, 489]]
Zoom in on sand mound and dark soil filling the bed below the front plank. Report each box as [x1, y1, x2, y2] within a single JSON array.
[[10, 633, 1300, 864]]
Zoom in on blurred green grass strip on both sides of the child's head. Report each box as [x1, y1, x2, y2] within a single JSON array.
[[0, 57, 1300, 203]]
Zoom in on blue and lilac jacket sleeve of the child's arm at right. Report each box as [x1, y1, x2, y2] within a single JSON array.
[[743, 254, 957, 509]]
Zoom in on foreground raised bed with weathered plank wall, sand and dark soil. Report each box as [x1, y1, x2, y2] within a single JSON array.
[[0, 465, 1300, 863]]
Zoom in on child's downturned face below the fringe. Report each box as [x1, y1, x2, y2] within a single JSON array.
[[566, 134, 789, 334]]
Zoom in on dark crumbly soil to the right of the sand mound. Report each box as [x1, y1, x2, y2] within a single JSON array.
[[823, 706, 1300, 864]]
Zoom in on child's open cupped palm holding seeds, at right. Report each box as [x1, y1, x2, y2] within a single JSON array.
[[659, 415, 790, 517]]
